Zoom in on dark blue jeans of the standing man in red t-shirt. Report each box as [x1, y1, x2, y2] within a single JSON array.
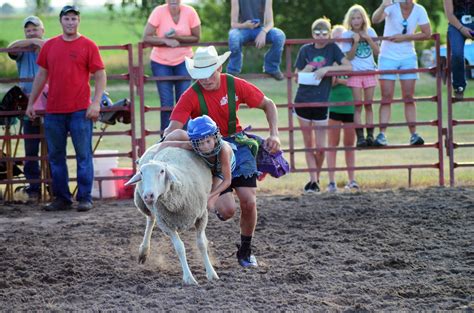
[[44, 110, 94, 202]]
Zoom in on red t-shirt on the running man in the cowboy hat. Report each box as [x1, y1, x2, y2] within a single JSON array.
[[171, 74, 265, 137]]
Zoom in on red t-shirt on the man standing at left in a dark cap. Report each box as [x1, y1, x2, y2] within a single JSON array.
[[37, 35, 104, 113]]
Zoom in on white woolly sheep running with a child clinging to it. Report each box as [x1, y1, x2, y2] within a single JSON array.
[[126, 145, 219, 285]]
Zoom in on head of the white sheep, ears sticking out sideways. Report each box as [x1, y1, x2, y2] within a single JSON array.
[[126, 161, 176, 204]]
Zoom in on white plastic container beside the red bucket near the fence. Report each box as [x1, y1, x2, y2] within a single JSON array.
[[92, 150, 118, 198]]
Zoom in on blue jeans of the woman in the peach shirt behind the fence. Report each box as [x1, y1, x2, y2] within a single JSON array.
[[150, 61, 191, 131]]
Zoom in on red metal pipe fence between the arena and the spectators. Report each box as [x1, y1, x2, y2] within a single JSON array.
[[0, 34, 474, 202]]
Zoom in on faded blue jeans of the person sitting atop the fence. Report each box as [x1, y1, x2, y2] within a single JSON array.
[[227, 27, 286, 73]]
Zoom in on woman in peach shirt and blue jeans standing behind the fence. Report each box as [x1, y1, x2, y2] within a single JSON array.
[[143, 0, 201, 131]]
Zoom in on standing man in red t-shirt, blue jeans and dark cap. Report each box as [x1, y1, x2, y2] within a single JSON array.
[[26, 5, 107, 211]]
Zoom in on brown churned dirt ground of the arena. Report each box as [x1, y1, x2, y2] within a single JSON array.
[[0, 188, 474, 312]]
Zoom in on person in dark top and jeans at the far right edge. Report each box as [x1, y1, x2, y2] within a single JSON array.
[[444, 0, 474, 100]]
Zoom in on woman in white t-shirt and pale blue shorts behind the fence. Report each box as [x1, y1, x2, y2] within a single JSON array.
[[372, 0, 431, 146]]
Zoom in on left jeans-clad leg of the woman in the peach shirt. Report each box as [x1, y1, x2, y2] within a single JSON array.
[[150, 61, 174, 131]]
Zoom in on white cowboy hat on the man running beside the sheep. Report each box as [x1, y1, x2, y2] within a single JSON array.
[[185, 46, 230, 79]]
